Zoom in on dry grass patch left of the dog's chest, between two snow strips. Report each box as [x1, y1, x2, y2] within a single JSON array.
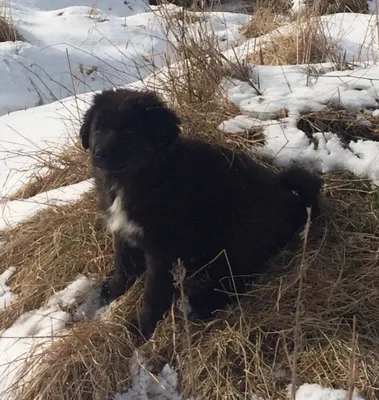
[[0, 193, 113, 328]]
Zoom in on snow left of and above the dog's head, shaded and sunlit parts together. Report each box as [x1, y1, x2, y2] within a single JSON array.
[[0, 0, 248, 202]]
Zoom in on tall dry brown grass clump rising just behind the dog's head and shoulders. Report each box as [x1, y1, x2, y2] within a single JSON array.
[[154, 10, 264, 149]]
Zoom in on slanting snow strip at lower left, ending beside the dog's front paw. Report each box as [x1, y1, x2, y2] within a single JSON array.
[[0, 277, 92, 400]]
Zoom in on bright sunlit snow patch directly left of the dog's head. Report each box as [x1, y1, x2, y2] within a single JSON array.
[[0, 94, 93, 203]]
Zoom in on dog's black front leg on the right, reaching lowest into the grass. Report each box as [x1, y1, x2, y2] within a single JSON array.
[[135, 257, 174, 339]]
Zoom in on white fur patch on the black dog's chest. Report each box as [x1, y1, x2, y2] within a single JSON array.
[[107, 193, 143, 245]]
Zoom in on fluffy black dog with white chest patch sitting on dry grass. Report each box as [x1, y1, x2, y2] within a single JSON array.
[[80, 89, 321, 337]]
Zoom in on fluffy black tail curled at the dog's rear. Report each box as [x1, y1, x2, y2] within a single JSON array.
[[279, 166, 322, 217]]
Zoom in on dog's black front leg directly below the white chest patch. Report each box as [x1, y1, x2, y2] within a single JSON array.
[[101, 234, 145, 302]]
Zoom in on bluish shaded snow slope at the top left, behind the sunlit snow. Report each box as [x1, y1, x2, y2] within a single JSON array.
[[0, 0, 249, 115]]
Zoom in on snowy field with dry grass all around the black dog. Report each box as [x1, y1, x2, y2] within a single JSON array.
[[0, 0, 379, 400]]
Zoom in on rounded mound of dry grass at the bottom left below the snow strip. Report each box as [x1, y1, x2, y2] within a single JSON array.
[[18, 319, 138, 400]]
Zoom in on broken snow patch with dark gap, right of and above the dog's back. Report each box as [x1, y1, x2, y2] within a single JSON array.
[[219, 65, 379, 185]]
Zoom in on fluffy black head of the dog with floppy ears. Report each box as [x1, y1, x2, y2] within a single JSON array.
[[80, 89, 180, 172]]
